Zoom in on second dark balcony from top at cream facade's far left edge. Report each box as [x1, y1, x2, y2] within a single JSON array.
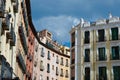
[[2, 14, 11, 30]]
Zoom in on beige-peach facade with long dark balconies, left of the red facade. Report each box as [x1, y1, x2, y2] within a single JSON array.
[[15, 0, 28, 80]]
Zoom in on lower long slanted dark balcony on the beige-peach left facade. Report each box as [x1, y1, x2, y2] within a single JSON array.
[[17, 50, 26, 73]]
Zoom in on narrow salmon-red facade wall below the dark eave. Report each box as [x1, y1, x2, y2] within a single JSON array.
[[26, 26, 35, 80]]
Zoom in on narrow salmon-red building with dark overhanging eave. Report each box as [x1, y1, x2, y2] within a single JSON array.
[[25, 0, 37, 80]]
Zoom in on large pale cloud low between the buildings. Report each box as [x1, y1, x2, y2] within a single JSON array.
[[33, 15, 79, 44]]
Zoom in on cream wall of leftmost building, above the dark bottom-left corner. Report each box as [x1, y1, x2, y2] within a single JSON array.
[[0, 0, 18, 77]]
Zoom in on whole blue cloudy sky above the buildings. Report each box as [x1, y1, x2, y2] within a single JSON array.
[[31, 0, 120, 46]]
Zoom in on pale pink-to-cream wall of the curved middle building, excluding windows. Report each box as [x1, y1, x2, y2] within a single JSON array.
[[33, 30, 70, 80]]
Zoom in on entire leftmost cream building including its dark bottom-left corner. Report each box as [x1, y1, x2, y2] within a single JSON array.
[[0, 0, 18, 80]]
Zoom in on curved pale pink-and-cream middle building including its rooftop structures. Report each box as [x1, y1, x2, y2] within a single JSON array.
[[33, 30, 70, 80]]
